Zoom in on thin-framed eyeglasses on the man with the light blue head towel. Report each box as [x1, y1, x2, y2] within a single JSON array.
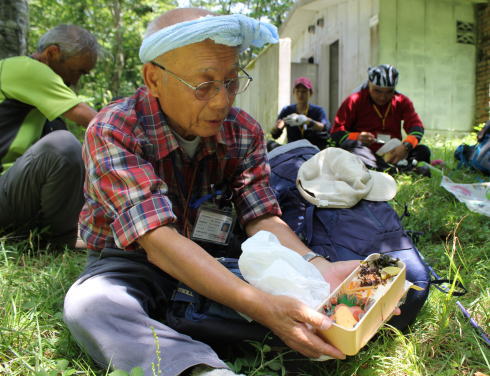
[[150, 61, 253, 101]]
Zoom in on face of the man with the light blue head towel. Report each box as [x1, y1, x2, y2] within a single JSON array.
[[144, 40, 238, 139]]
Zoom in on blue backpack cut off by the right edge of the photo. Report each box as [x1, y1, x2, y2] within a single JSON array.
[[454, 120, 490, 175]]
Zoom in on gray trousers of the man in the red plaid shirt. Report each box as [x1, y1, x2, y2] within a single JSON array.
[[64, 248, 228, 376]]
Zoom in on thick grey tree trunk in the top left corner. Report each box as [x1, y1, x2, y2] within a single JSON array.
[[0, 0, 29, 59]]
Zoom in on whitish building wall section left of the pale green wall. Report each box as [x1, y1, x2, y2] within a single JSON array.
[[281, 0, 379, 117]]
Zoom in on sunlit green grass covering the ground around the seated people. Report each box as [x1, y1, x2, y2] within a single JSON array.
[[0, 137, 490, 376]]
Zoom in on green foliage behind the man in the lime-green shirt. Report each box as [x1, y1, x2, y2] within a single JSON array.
[[28, 0, 176, 109]]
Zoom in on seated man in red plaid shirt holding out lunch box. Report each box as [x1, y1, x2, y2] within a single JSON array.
[[64, 8, 356, 376]]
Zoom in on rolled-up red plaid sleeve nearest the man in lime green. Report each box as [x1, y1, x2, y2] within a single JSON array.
[[81, 123, 176, 249]]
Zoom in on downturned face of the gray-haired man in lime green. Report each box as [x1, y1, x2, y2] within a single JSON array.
[[48, 53, 97, 86]]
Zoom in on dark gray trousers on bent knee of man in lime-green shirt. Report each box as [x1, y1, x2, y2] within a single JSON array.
[[0, 130, 84, 246]]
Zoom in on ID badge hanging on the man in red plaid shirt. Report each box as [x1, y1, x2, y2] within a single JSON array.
[[191, 207, 235, 245]]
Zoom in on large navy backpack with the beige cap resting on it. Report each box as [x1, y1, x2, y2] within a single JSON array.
[[269, 140, 431, 330]]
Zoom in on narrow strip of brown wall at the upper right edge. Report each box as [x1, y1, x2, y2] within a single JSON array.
[[475, 4, 490, 123]]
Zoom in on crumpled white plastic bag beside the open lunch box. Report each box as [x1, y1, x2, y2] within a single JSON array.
[[238, 231, 330, 309]]
